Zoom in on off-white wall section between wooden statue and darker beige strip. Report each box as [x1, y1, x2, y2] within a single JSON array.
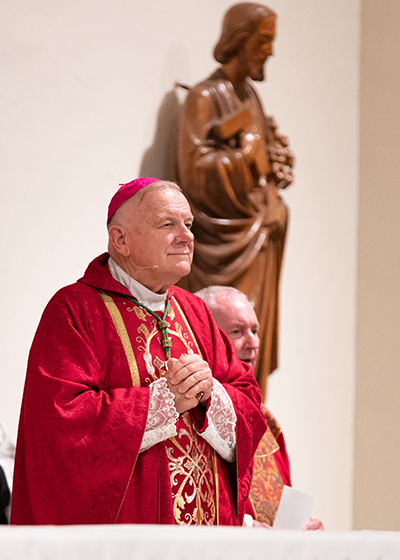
[[264, 1, 359, 529]]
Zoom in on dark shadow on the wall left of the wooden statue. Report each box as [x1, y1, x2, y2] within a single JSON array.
[[140, 89, 181, 181]]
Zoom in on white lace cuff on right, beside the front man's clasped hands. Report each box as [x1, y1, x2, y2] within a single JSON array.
[[200, 379, 236, 463]]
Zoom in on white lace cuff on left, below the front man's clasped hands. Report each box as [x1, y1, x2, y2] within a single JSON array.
[[139, 377, 179, 453]]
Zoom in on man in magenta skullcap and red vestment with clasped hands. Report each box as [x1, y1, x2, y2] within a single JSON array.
[[11, 178, 265, 525]]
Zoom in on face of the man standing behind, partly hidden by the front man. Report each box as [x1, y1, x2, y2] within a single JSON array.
[[214, 294, 260, 369]]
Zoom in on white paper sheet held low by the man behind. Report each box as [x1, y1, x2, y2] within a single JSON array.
[[274, 486, 314, 529]]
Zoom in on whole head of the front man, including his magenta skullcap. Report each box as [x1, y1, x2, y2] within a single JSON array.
[[107, 177, 193, 293]]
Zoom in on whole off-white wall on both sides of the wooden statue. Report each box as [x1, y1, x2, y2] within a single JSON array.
[[0, 0, 359, 529]]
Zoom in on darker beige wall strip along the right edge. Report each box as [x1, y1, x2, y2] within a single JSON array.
[[354, 0, 400, 531]]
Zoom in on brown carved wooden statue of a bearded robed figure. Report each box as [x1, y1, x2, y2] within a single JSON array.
[[177, 3, 294, 396]]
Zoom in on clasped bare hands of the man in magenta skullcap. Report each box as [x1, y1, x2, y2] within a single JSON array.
[[165, 354, 213, 414]]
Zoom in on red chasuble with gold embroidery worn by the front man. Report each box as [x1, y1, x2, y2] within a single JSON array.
[[11, 254, 265, 525]]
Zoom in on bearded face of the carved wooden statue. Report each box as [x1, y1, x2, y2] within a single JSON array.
[[238, 16, 275, 82]]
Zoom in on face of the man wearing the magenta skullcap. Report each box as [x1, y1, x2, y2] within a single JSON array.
[[125, 188, 193, 293]]
